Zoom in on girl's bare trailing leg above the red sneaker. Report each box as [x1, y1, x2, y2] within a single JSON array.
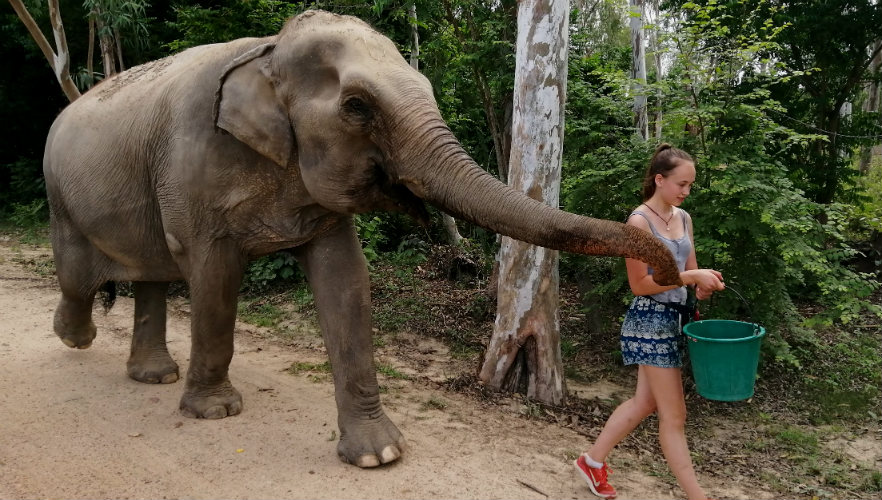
[[588, 365, 656, 462]]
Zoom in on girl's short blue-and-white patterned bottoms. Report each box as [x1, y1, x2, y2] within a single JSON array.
[[621, 296, 686, 368]]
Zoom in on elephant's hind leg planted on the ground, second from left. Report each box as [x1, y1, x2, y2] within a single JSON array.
[[126, 281, 180, 384]]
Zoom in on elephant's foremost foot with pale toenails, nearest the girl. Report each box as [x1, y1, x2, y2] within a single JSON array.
[[337, 413, 406, 469]]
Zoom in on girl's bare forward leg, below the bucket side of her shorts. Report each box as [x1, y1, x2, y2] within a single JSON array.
[[640, 366, 707, 500]]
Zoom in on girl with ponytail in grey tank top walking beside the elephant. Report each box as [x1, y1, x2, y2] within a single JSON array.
[[576, 144, 724, 500]]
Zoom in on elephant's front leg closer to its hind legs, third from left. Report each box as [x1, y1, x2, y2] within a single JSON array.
[[180, 241, 245, 419]]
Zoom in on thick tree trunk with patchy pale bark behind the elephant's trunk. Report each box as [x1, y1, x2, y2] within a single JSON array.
[[479, 0, 569, 404]]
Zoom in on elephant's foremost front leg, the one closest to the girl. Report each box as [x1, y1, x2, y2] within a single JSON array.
[[298, 219, 405, 467]]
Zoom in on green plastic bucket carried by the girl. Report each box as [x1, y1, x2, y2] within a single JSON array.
[[683, 319, 766, 401]]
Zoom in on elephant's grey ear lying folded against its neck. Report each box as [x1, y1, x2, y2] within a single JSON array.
[[214, 44, 294, 166]]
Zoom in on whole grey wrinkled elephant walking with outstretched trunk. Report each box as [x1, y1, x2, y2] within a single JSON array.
[[44, 8, 679, 467]]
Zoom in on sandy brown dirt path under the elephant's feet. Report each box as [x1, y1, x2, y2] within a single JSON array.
[[0, 243, 771, 500]]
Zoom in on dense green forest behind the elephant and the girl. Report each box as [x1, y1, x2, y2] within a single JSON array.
[[0, 0, 882, 491]]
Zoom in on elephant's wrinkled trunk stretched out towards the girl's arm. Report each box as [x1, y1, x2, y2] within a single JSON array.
[[396, 116, 682, 285]]
